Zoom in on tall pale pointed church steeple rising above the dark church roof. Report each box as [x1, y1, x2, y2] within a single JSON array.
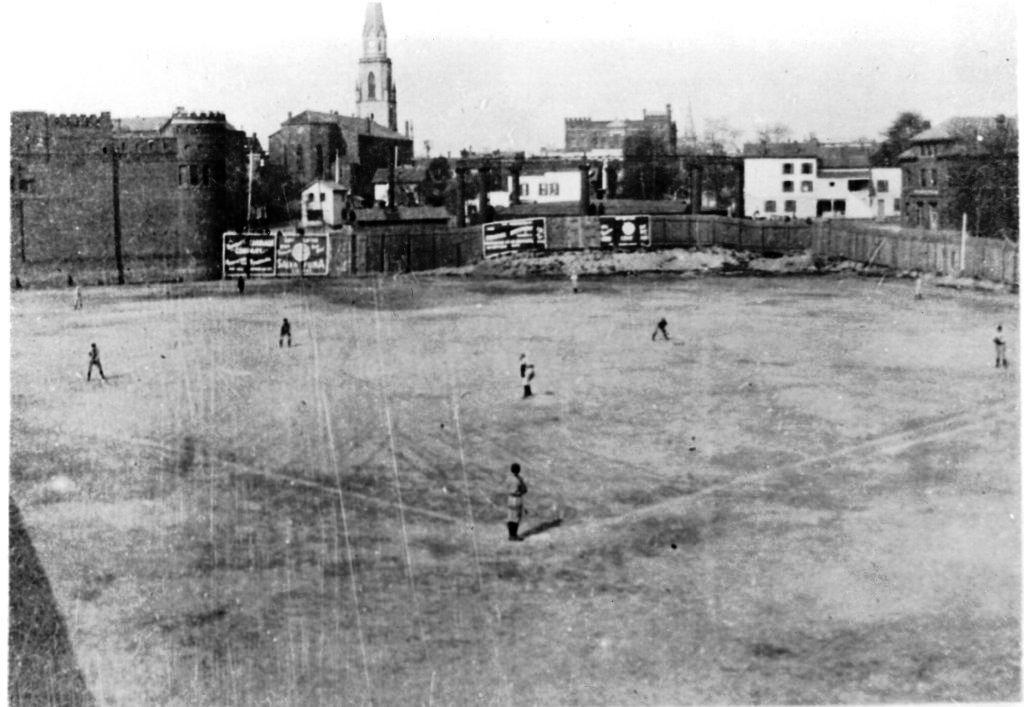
[[355, 2, 398, 130]]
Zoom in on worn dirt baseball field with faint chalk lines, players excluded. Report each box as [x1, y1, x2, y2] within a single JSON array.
[[11, 266, 1021, 705]]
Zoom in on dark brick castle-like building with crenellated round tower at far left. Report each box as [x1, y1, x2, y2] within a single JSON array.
[[10, 109, 255, 271]]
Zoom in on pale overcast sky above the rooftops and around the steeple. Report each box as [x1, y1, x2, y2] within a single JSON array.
[[3, 0, 1018, 155]]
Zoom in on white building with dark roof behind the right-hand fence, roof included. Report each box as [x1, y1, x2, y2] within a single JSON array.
[[743, 140, 902, 219]]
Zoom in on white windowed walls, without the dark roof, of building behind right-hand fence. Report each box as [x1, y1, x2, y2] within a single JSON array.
[[743, 157, 902, 219]]
